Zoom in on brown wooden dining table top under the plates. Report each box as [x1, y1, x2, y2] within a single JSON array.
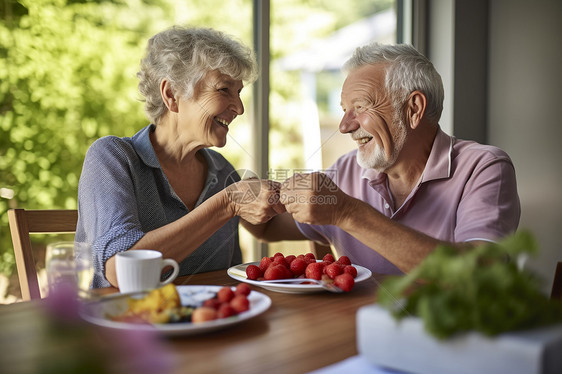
[[0, 270, 384, 374]]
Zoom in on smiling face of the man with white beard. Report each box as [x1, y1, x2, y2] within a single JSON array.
[[339, 64, 407, 172]]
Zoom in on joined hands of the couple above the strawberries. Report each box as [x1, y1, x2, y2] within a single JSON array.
[[227, 172, 349, 225]]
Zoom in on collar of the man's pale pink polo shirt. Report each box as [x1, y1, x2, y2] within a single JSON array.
[[361, 127, 455, 184]]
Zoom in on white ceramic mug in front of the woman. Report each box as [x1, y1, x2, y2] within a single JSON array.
[[115, 249, 180, 293]]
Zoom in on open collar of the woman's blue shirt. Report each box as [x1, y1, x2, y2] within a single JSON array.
[[132, 124, 227, 177]]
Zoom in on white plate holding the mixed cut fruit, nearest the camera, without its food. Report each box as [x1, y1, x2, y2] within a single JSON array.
[[81, 286, 271, 336]]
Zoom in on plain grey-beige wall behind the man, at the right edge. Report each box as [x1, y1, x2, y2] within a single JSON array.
[[487, 0, 562, 290]]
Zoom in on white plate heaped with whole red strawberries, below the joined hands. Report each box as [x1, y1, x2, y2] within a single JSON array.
[[227, 252, 372, 293]]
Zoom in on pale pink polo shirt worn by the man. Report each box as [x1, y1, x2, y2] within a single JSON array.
[[297, 129, 521, 274]]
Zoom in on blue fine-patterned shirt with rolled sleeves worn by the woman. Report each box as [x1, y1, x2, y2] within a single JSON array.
[[75, 125, 242, 287]]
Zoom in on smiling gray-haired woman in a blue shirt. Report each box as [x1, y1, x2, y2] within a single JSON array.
[[76, 27, 283, 287]]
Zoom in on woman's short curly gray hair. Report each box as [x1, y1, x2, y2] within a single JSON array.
[[137, 26, 258, 124]]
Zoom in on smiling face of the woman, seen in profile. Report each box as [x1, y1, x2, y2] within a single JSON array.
[[178, 70, 244, 147]]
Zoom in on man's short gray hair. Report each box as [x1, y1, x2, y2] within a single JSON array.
[[343, 43, 445, 122]]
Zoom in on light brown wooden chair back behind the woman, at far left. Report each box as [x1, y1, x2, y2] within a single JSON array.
[[8, 209, 78, 300]]
